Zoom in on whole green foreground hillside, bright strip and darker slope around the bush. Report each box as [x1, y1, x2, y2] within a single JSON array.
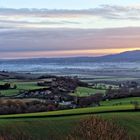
[[0, 98, 140, 140]]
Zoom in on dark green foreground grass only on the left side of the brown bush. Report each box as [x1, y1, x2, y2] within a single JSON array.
[[0, 116, 85, 140]]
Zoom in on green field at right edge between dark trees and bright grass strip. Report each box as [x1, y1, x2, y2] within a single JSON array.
[[101, 97, 140, 106]]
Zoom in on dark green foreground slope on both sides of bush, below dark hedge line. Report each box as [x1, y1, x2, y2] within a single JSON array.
[[0, 112, 140, 140]]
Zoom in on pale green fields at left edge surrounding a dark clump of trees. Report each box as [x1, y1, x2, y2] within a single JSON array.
[[0, 81, 44, 96]]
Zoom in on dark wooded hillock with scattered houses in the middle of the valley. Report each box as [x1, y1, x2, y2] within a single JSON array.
[[21, 77, 88, 101]]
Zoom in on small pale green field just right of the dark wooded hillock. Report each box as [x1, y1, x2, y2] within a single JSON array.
[[72, 87, 105, 97]]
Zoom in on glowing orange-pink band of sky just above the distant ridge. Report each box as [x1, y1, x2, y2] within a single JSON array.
[[1, 48, 140, 58]]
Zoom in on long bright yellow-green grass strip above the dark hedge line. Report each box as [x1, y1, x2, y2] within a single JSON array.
[[0, 105, 134, 119]]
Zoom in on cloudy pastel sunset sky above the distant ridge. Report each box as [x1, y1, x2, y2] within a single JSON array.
[[0, 0, 140, 58]]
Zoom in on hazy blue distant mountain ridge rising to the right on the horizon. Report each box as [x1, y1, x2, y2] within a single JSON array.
[[0, 50, 140, 64]]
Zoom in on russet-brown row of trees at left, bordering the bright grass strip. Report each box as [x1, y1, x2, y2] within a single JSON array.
[[0, 100, 56, 114]]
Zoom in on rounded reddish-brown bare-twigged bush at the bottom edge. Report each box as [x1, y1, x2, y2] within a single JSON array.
[[67, 116, 130, 140]]
